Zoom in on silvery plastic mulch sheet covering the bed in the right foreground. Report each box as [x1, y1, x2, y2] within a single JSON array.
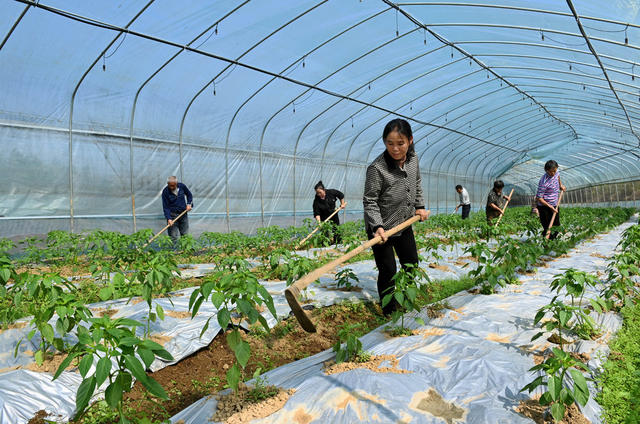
[[172, 219, 632, 424]]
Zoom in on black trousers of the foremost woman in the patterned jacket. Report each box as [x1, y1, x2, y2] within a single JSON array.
[[368, 227, 418, 315]]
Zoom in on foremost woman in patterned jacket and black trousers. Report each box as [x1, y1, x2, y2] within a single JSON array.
[[363, 119, 429, 315]]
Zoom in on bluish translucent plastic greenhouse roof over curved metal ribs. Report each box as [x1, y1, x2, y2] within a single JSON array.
[[0, 0, 640, 232]]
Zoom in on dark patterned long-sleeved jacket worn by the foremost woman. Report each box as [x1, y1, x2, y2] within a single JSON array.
[[362, 150, 424, 235]]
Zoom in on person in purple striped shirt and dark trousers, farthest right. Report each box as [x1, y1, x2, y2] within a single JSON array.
[[536, 160, 566, 239]]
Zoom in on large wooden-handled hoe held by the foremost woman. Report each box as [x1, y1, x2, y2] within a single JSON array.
[[284, 215, 420, 333]]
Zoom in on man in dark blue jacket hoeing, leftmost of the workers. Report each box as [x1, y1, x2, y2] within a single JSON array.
[[162, 175, 193, 243]]
